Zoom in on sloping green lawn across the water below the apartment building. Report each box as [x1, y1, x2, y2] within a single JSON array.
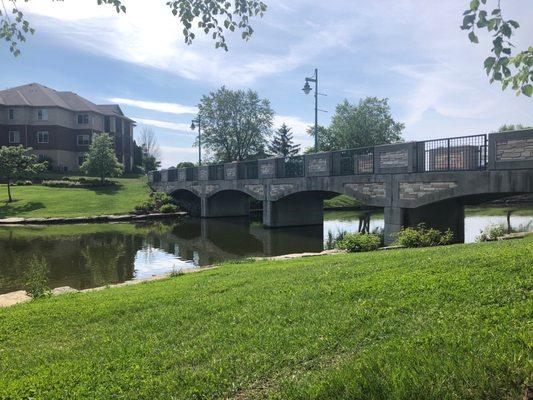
[[0, 177, 149, 218]]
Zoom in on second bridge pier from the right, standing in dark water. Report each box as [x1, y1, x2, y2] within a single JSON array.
[[263, 193, 324, 228]]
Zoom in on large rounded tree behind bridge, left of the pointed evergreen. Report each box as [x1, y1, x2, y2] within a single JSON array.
[[195, 86, 274, 162]]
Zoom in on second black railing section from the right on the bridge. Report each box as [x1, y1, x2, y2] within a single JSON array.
[[331, 147, 374, 175]]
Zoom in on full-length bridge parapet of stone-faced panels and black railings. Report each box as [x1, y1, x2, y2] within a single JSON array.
[[157, 130, 533, 183]]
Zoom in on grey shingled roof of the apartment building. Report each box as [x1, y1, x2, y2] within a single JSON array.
[[0, 83, 134, 122]]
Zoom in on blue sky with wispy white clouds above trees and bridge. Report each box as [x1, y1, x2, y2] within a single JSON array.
[[0, 0, 533, 167]]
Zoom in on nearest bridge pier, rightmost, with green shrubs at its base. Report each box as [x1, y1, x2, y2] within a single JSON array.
[[384, 200, 465, 245]]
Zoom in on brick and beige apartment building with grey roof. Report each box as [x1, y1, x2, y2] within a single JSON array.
[[0, 83, 135, 171]]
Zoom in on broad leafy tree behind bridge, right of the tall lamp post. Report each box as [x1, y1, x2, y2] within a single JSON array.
[[308, 97, 404, 151]]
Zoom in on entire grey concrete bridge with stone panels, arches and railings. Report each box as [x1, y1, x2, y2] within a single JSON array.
[[149, 130, 533, 243]]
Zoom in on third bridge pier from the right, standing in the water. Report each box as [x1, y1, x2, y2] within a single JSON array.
[[201, 191, 250, 218]]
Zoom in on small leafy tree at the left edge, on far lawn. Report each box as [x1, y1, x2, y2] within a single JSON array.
[[0, 146, 46, 203]]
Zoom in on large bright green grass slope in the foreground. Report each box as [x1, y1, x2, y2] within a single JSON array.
[[0, 237, 533, 399]]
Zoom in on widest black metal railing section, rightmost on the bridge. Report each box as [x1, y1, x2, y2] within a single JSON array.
[[416, 135, 488, 172]]
